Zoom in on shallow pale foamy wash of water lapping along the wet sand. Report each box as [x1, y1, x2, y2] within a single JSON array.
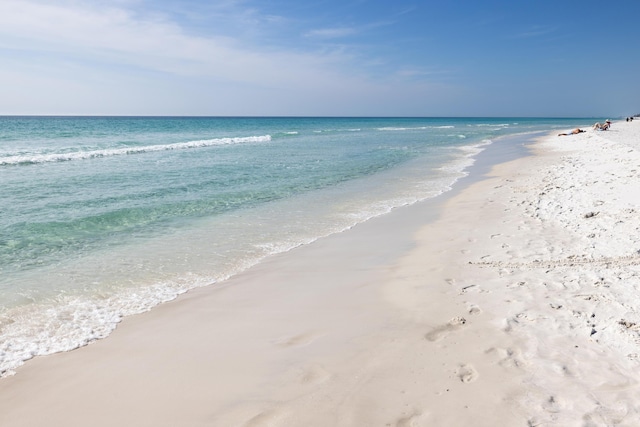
[[0, 123, 532, 378]]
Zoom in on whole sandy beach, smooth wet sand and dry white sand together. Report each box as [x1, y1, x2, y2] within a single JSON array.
[[0, 120, 640, 426]]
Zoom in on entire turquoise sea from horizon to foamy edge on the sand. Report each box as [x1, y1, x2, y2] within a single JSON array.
[[0, 117, 583, 374]]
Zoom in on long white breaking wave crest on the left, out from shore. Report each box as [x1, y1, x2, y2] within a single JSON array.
[[0, 135, 271, 166]]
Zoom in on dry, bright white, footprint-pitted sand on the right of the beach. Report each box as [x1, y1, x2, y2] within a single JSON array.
[[412, 122, 640, 426]]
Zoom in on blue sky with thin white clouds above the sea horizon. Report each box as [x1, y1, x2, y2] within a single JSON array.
[[0, 0, 640, 117]]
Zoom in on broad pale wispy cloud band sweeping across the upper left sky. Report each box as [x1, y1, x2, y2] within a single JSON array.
[[0, 0, 350, 82]]
